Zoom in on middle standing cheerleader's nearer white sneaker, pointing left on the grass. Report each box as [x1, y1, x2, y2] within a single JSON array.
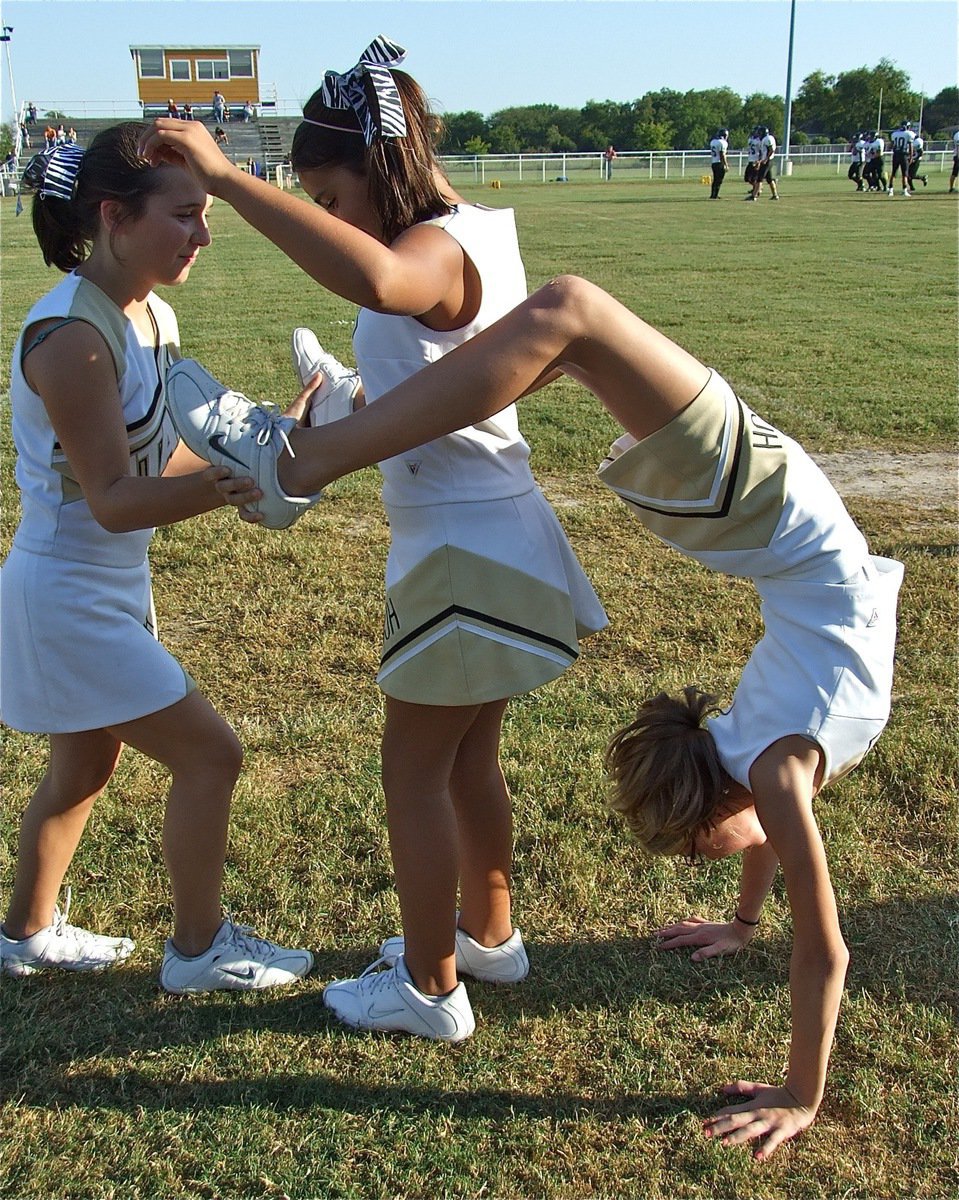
[[323, 954, 476, 1042]]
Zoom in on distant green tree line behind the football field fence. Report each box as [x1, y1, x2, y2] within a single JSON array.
[[442, 59, 959, 155]]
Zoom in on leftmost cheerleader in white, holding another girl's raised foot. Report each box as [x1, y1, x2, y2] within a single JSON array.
[[0, 129, 312, 992]]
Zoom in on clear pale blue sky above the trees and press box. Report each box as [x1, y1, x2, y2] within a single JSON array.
[[0, 0, 959, 120]]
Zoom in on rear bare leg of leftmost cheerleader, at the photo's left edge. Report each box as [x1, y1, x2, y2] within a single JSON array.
[[4, 730, 122, 938]]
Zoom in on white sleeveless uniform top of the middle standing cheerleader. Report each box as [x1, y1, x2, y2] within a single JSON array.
[[353, 204, 534, 506]]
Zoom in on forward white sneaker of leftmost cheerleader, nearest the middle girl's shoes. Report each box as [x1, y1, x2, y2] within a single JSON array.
[[160, 917, 313, 995]]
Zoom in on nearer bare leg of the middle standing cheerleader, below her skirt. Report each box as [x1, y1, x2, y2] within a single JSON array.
[[383, 696, 494, 996]]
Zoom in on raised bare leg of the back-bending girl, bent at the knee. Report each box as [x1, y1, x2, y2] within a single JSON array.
[[278, 276, 708, 496]]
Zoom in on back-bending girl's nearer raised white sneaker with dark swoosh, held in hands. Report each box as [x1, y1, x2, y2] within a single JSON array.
[[167, 359, 323, 529]]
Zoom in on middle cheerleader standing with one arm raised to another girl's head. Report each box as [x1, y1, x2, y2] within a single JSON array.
[[140, 38, 606, 1042]]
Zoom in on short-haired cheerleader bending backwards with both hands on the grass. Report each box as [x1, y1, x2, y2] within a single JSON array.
[[159, 276, 903, 1158]]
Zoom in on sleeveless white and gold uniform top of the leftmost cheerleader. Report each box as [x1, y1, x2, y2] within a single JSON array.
[[10, 272, 179, 566]]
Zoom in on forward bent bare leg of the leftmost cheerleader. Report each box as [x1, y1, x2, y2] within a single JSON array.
[[110, 691, 242, 955]]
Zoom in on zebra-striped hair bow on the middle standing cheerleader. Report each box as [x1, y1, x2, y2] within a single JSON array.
[[304, 34, 407, 146]]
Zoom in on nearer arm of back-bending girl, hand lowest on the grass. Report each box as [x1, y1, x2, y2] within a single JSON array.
[[706, 737, 849, 1159]]
